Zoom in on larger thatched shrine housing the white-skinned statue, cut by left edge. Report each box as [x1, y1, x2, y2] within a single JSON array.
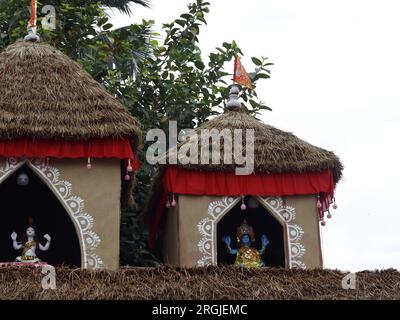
[[0, 36, 141, 269]]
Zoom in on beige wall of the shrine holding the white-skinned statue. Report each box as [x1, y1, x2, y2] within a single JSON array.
[[0, 158, 121, 270]]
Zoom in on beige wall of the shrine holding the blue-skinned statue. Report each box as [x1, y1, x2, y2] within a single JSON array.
[[164, 195, 322, 269]]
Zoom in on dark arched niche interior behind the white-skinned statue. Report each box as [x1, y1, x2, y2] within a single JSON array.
[[0, 165, 81, 267]]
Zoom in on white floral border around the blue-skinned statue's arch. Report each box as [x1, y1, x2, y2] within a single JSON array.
[[197, 197, 306, 269]]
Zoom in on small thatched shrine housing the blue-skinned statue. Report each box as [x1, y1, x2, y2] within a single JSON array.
[[146, 87, 343, 269]]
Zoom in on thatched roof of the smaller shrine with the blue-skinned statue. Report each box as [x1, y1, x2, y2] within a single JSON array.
[[167, 109, 343, 182]]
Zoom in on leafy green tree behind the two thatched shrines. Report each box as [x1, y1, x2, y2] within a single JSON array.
[[0, 0, 271, 265]]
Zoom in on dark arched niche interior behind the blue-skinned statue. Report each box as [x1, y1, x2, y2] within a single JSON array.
[[217, 197, 285, 267]]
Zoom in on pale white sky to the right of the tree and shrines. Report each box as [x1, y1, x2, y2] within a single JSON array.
[[108, 0, 400, 271]]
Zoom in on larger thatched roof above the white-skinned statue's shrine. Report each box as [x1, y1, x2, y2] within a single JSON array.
[[0, 41, 141, 145]]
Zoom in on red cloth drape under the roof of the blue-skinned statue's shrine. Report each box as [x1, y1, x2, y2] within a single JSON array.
[[149, 167, 334, 245]]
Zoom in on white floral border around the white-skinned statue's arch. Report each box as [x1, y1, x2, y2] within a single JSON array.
[[0, 158, 105, 269]]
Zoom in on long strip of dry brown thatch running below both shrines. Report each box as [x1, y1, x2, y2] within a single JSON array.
[[0, 267, 400, 299]]
